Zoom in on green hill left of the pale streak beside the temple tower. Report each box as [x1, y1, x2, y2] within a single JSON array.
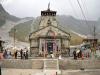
[[9, 20, 32, 41]]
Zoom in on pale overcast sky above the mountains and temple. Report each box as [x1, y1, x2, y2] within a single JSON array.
[[2, 0, 100, 20]]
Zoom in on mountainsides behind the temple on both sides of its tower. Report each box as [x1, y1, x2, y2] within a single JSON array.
[[9, 15, 100, 45]]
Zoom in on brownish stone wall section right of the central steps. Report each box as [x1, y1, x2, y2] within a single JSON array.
[[59, 60, 100, 70]]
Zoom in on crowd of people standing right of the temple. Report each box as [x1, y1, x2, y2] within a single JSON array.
[[73, 48, 100, 59]]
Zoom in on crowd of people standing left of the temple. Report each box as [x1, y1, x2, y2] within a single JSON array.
[[0, 48, 29, 59]]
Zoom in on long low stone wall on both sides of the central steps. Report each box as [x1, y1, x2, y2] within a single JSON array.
[[0, 59, 100, 70]]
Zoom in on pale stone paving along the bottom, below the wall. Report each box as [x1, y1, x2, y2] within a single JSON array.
[[2, 68, 100, 75]]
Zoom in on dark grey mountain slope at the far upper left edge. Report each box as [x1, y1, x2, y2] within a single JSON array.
[[0, 4, 20, 26]]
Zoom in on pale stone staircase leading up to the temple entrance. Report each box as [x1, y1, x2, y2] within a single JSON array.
[[44, 59, 61, 75]]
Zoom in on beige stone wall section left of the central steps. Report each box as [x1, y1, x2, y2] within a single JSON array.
[[0, 59, 43, 69]]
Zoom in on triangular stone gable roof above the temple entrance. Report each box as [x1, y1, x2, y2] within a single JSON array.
[[29, 25, 71, 39]]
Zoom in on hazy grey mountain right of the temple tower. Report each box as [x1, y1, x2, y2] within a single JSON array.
[[57, 15, 97, 35]]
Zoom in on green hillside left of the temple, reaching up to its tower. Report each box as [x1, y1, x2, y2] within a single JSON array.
[[9, 18, 40, 42]]
